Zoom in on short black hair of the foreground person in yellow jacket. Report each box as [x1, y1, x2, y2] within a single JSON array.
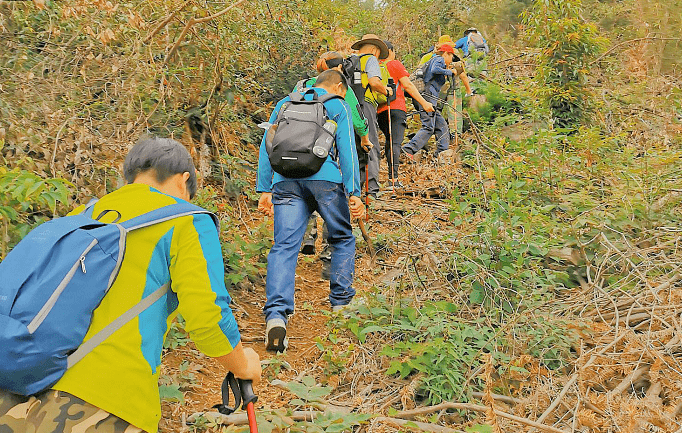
[[123, 137, 197, 198]]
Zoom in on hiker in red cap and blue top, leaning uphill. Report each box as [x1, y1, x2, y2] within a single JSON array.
[[402, 44, 459, 160]]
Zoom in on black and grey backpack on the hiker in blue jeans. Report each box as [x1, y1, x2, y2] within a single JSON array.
[[265, 89, 343, 179]]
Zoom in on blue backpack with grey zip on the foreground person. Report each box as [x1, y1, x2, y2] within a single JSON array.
[[0, 201, 218, 396]]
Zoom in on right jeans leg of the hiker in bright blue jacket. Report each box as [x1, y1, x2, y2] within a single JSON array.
[[311, 181, 355, 306]]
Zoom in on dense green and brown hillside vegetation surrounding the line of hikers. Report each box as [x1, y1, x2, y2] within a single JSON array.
[[0, 0, 682, 432]]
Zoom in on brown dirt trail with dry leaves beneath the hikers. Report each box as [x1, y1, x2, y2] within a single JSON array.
[[160, 157, 443, 432]]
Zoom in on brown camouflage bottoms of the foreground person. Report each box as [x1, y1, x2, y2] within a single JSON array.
[[0, 390, 142, 433]]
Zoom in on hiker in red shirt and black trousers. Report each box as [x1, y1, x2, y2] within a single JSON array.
[[377, 41, 434, 188]]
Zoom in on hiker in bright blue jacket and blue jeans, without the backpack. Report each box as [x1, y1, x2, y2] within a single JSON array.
[[256, 69, 365, 352]]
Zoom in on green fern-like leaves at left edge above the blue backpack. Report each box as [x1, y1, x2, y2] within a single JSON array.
[[0, 166, 72, 259]]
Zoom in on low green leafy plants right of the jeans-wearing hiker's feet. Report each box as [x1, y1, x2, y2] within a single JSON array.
[[337, 295, 577, 404]]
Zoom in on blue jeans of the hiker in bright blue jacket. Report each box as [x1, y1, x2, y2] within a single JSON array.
[[263, 180, 355, 322]]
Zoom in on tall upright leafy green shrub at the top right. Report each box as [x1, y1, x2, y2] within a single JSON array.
[[523, 0, 606, 128]]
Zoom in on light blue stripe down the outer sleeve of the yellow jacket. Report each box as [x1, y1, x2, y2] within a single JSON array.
[[193, 214, 241, 348]]
